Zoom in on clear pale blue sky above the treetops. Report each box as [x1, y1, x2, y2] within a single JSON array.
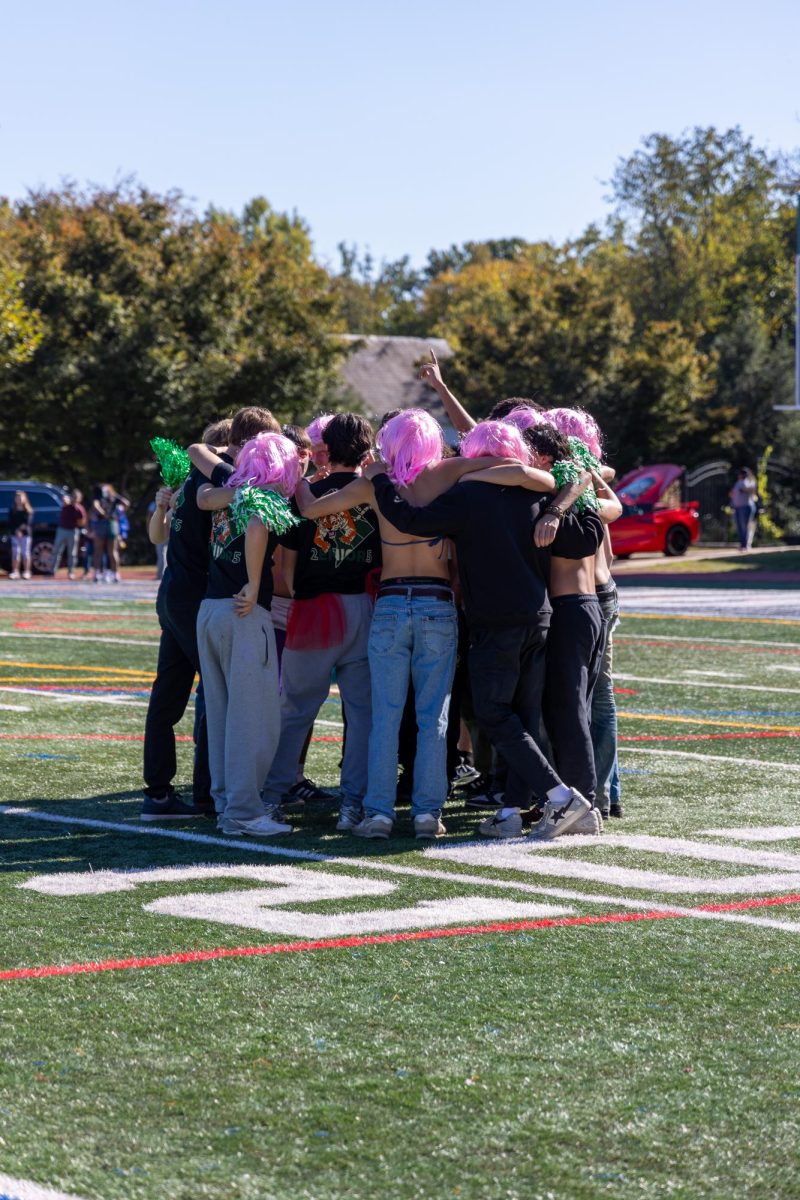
[[0, 0, 800, 270]]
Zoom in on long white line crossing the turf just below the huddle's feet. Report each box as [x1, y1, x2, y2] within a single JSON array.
[[0, 805, 784, 929]]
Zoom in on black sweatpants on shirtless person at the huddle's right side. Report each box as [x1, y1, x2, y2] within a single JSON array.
[[545, 594, 603, 804]]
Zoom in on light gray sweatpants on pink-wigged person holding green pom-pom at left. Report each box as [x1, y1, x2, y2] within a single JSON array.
[[197, 600, 281, 821]]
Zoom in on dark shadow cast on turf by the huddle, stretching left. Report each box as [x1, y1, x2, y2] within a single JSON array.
[[0, 791, 483, 874]]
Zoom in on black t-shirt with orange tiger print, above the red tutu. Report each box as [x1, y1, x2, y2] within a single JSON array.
[[281, 470, 380, 600]]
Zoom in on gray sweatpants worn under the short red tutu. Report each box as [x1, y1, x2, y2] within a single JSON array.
[[264, 594, 372, 808]]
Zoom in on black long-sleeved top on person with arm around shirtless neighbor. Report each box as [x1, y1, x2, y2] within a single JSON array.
[[372, 475, 603, 628]]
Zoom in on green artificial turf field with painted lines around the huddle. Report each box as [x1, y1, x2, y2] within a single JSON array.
[[0, 586, 800, 1200]]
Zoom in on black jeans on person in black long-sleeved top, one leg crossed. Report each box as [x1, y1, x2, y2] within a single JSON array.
[[469, 624, 561, 809]]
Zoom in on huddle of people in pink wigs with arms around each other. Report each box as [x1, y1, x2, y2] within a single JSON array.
[[142, 355, 621, 840]]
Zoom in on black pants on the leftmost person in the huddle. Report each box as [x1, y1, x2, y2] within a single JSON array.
[[144, 587, 211, 800]]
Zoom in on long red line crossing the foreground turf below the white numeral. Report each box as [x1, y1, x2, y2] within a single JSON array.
[[6, 894, 800, 980]]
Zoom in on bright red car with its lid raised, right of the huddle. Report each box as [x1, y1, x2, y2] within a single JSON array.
[[610, 462, 700, 558]]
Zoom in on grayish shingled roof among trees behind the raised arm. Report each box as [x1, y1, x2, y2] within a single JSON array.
[[341, 334, 453, 433]]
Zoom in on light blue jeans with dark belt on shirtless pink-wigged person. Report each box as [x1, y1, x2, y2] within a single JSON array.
[[363, 596, 458, 818]]
